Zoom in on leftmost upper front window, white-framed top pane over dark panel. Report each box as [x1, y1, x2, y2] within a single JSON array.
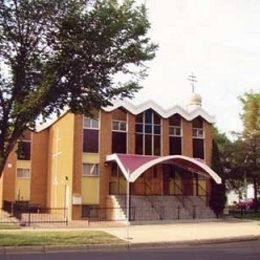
[[83, 114, 99, 153]]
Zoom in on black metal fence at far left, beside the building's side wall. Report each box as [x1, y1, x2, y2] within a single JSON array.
[[0, 201, 68, 226]]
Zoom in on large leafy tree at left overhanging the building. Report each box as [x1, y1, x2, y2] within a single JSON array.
[[0, 0, 157, 176]]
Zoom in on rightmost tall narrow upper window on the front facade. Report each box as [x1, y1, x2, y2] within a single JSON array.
[[192, 117, 204, 159]]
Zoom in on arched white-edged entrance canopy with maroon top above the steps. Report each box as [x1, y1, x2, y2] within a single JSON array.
[[106, 154, 222, 184]]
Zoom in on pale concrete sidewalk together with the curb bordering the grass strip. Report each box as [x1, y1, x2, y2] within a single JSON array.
[[0, 221, 260, 255]]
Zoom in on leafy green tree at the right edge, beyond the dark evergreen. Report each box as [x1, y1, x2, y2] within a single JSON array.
[[227, 92, 260, 210]]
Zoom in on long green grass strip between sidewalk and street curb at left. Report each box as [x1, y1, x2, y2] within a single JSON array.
[[0, 231, 123, 246]]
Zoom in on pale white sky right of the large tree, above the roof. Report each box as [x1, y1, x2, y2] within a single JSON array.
[[134, 0, 260, 133]]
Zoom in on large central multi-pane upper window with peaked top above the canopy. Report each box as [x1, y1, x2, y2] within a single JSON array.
[[135, 109, 161, 155]]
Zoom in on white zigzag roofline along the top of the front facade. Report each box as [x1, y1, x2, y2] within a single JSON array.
[[102, 100, 215, 123]]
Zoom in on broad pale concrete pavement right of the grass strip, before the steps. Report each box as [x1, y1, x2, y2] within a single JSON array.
[[95, 221, 260, 245]]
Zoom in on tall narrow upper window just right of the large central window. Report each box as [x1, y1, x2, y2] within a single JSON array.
[[169, 114, 182, 155]]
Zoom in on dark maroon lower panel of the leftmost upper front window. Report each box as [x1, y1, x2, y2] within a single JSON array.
[[83, 129, 99, 153]]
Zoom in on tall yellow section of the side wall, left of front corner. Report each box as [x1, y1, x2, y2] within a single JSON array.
[[48, 113, 75, 219]]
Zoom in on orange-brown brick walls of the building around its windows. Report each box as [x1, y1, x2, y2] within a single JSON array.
[[2, 99, 215, 219]]
